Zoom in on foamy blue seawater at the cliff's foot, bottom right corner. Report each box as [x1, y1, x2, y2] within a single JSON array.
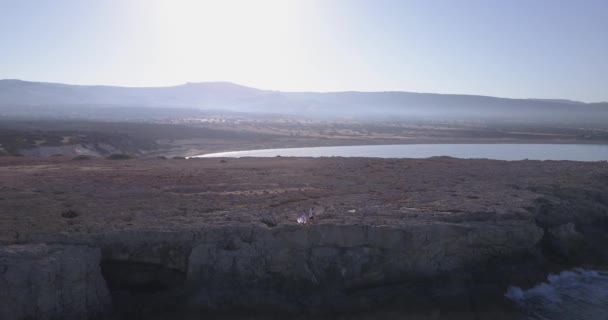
[[505, 269, 608, 320]]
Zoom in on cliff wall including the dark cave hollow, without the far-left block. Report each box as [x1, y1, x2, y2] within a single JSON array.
[[72, 221, 543, 312]]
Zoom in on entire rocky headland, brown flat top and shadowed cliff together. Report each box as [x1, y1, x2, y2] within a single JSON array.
[[0, 157, 608, 319]]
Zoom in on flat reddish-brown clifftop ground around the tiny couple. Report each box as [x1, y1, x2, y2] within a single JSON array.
[[0, 157, 608, 243]]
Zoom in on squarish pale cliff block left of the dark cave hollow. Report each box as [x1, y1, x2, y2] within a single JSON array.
[[0, 244, 111, 320]]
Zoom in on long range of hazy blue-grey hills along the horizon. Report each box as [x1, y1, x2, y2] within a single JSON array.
[[0, 80, 608, 122]]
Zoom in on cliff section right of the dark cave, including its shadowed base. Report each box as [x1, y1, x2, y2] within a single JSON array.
[[187, 222, 543, 311]]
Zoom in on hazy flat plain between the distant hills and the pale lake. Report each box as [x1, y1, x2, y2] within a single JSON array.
[[0, 115, 608, 159]]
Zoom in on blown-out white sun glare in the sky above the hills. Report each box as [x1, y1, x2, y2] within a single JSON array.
[[136, 0, 302, 86]]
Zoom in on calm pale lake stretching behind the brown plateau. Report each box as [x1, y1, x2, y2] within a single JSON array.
[[196, 144, 608, 161]]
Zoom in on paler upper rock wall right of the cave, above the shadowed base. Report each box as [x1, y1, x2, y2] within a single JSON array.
[[188, 222, 543, 287]]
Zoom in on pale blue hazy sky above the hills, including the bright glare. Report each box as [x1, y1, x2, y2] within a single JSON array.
[[0, 0, 608, 101]]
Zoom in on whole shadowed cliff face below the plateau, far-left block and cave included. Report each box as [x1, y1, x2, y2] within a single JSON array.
[[0, 222, 543, 319]]
